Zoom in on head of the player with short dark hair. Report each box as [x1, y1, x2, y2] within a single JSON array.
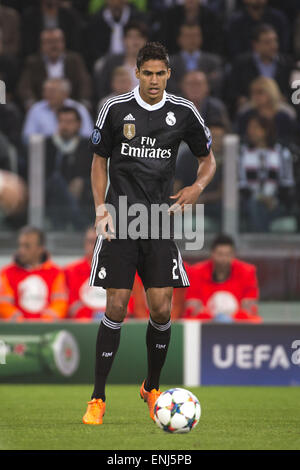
[[136, 60, 171, 104]]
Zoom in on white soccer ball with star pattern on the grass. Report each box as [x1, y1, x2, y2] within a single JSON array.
[[154, 388, 201, 433]]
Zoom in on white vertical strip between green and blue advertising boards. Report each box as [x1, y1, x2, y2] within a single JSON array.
[[183, 320, 202, 387]]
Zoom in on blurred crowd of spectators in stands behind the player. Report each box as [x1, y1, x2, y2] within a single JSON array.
[[0, 0, 300, 232]]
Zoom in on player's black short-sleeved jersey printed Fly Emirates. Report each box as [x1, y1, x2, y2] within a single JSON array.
[[91, 87, 211, 238]]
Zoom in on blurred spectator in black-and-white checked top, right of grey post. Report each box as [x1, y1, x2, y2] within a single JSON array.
[[239, 116, 295, 232]]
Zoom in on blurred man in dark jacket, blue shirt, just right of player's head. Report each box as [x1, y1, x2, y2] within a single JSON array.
[[167, 24, 223, 95]]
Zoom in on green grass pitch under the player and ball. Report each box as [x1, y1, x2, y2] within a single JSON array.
[[0, 385, 300, 450]]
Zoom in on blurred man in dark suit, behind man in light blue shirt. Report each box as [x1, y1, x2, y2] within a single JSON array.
[[18, 29, 91, 110]]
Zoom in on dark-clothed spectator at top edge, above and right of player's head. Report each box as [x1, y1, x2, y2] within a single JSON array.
[[157, 0, 223, 54]]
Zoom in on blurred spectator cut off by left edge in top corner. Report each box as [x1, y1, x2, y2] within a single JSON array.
[[0, 5, 20, 56]]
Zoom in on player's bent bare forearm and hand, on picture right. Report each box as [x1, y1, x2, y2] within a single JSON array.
[[169, 150, 216, 212]]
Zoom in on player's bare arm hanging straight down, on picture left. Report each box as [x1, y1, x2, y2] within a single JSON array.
[[91, 153, 115, 241]]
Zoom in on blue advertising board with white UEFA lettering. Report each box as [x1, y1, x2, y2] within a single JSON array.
[[199, 324, 300, 385]]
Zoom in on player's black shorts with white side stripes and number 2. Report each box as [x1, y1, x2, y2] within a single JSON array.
[[89, 236, 190, 290]]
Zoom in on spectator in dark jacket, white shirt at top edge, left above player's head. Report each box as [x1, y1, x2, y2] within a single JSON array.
[[87, 0, 145, 67]]
